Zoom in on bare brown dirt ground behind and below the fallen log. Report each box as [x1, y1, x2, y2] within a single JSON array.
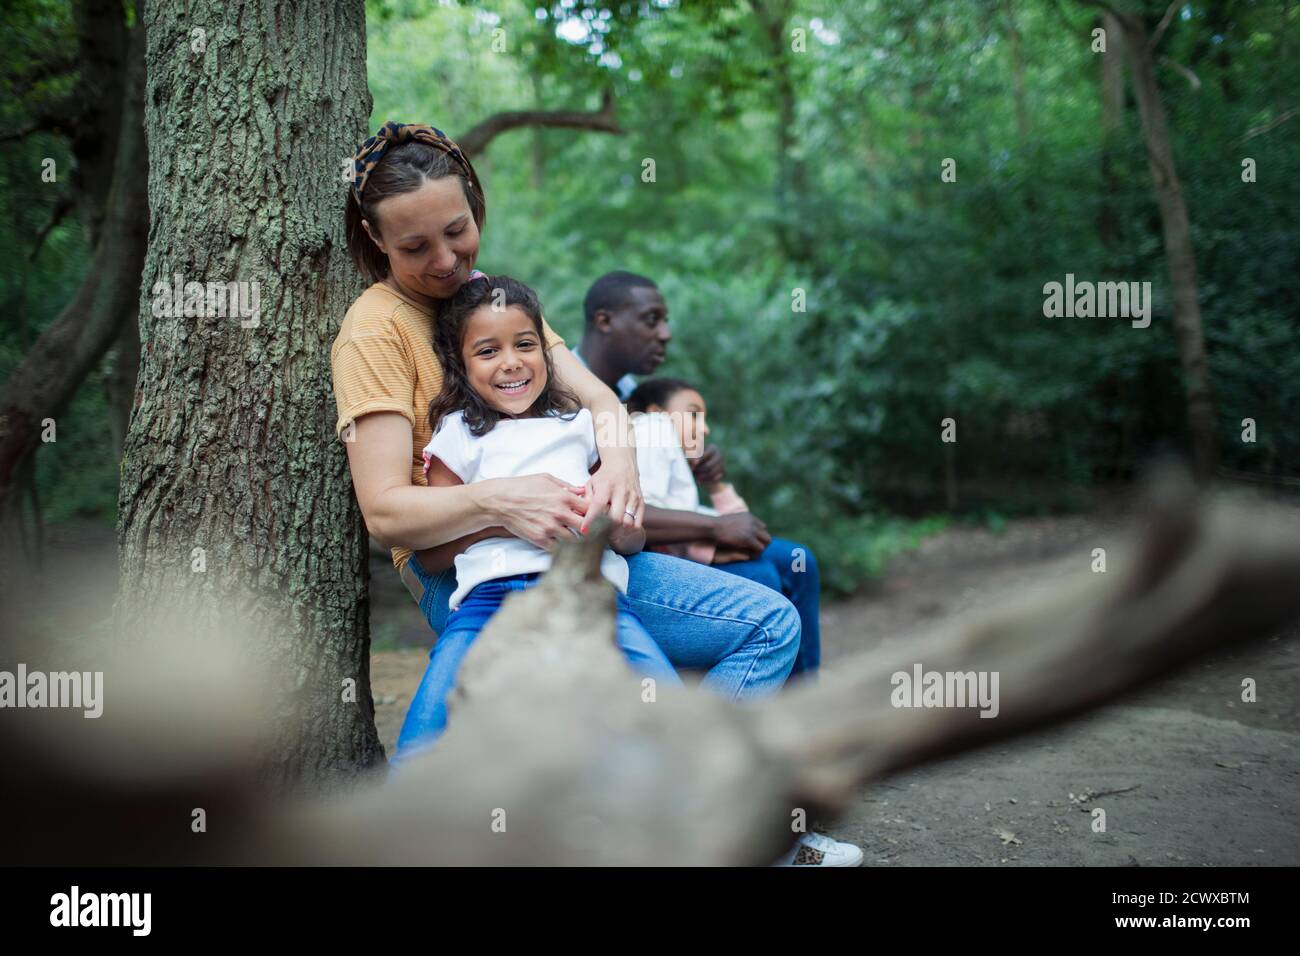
[[372, 511, 1300, 866]]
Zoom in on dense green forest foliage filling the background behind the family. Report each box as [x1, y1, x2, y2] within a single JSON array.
[[0, 0, 1300, 588]]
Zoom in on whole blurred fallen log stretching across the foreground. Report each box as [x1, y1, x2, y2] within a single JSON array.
[[0, 480, 1300, 865]]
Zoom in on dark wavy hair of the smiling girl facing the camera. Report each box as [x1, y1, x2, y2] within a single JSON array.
[[429, 276, 582, 438]]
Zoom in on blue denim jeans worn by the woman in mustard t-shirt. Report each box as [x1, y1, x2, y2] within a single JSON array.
[[393, 551, 800, 765]]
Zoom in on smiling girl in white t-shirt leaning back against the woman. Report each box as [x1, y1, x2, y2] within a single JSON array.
[[398, 273, 681, 750]]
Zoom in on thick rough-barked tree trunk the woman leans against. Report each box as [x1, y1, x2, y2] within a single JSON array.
[[116, 0, 385, 790]]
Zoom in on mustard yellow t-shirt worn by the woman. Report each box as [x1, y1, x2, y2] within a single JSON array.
[[330, 282, 564, 568]]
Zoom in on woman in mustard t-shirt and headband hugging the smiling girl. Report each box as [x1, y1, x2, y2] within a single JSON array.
[[332, 122, 863, 868]]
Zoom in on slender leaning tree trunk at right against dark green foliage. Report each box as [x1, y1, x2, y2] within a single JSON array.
[[1119, 14, 1218, 477]]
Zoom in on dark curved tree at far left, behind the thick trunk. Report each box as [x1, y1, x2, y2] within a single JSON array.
[[0, 0, 148, 540]]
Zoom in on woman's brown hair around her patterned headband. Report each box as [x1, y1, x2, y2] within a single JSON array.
[[345, 142, 488, 282]]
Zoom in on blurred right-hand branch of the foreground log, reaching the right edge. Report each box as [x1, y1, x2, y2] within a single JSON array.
[[768, 479, 1300, 806]]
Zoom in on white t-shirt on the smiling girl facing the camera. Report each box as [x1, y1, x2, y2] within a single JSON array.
[[424, 408, 628, 610]]
